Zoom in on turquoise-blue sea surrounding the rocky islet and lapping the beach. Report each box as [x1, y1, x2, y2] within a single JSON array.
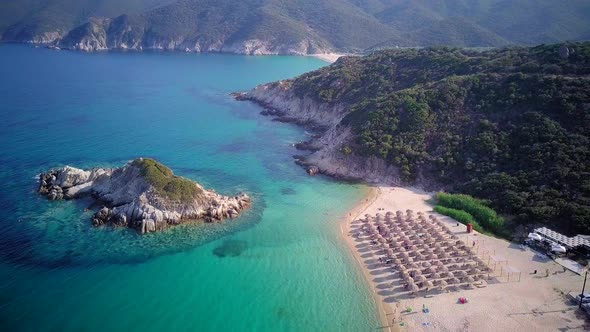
[[0, 44, 379, 331]]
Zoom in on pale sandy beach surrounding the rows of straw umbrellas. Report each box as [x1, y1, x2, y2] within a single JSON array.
[[341, 186, 590, 331]]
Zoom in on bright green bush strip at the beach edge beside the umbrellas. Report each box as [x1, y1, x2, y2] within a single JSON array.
[[436, 192, 504, 233]]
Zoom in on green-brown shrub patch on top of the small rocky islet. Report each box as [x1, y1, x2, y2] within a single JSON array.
[[132, 158, 202, 202]]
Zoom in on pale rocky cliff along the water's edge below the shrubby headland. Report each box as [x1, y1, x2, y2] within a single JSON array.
[[236, 81, 400, 184]]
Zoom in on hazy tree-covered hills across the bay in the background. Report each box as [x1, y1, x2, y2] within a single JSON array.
[[0, 0, 590, 51]]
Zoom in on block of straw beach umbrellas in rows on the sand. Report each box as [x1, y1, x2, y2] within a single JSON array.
[[361, 210, 492, 293]]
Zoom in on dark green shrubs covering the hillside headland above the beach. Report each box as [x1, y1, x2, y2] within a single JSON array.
[[290, 43, 590, 233]]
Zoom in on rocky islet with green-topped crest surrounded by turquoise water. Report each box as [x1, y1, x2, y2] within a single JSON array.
[[39, 158, 251, 234]]
